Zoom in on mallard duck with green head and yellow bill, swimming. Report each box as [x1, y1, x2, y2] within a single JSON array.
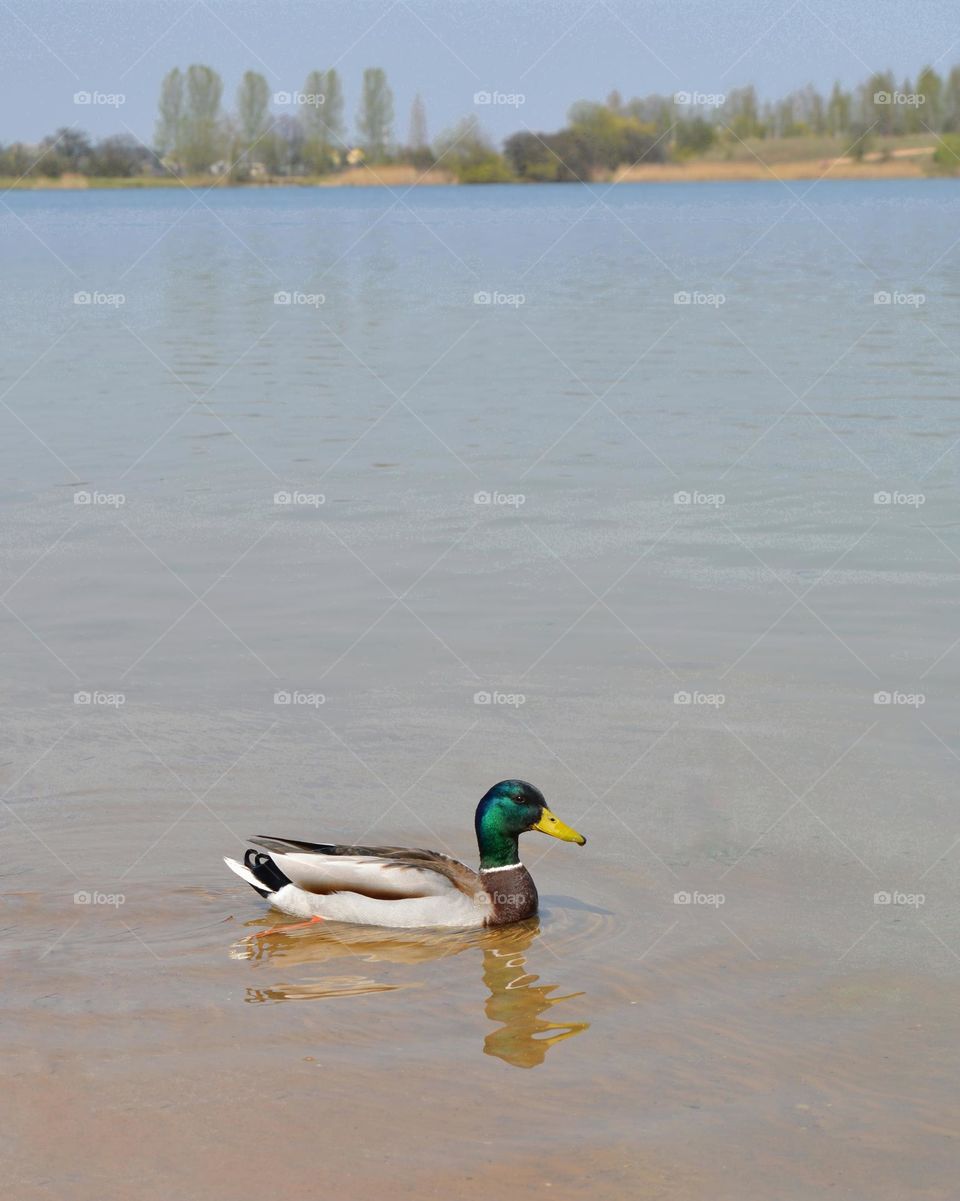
[[223, 779, 586, 930]]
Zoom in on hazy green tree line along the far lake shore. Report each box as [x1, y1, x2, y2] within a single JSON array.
[[0, 64, 960, 183]]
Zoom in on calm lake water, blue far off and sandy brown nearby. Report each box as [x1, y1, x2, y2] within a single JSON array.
[[0, 180, 960, 1201]]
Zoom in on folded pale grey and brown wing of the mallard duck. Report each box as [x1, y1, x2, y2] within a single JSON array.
[[250, 835, 482, 901]]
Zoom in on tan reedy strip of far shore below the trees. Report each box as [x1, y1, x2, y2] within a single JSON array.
[[0, 147, 952, 191]]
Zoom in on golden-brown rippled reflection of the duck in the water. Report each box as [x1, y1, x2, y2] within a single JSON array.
[[231, 918, 590, 1068]]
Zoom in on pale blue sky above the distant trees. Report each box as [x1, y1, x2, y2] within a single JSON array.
[[0, 0, 960, 142]]
